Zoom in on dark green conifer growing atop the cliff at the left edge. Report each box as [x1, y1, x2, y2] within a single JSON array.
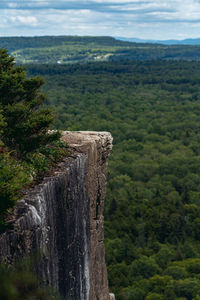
[[0, 49, 60, 157]]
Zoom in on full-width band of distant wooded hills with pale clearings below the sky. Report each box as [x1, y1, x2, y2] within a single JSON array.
[[0, 36, 200, 64]]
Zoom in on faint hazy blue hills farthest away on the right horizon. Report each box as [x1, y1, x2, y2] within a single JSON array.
[[116, 37, 200, 45]]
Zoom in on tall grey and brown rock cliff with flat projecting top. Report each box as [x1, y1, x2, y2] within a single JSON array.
[[0, 131, 112, 300]]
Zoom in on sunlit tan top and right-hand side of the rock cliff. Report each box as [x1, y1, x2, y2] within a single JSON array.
[[63, 131, 112, 300]]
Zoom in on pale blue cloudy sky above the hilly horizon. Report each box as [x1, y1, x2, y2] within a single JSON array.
[[0, 0, 200, 40]]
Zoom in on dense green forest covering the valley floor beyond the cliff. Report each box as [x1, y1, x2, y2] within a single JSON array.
[[28, 60, 200, 300]]
